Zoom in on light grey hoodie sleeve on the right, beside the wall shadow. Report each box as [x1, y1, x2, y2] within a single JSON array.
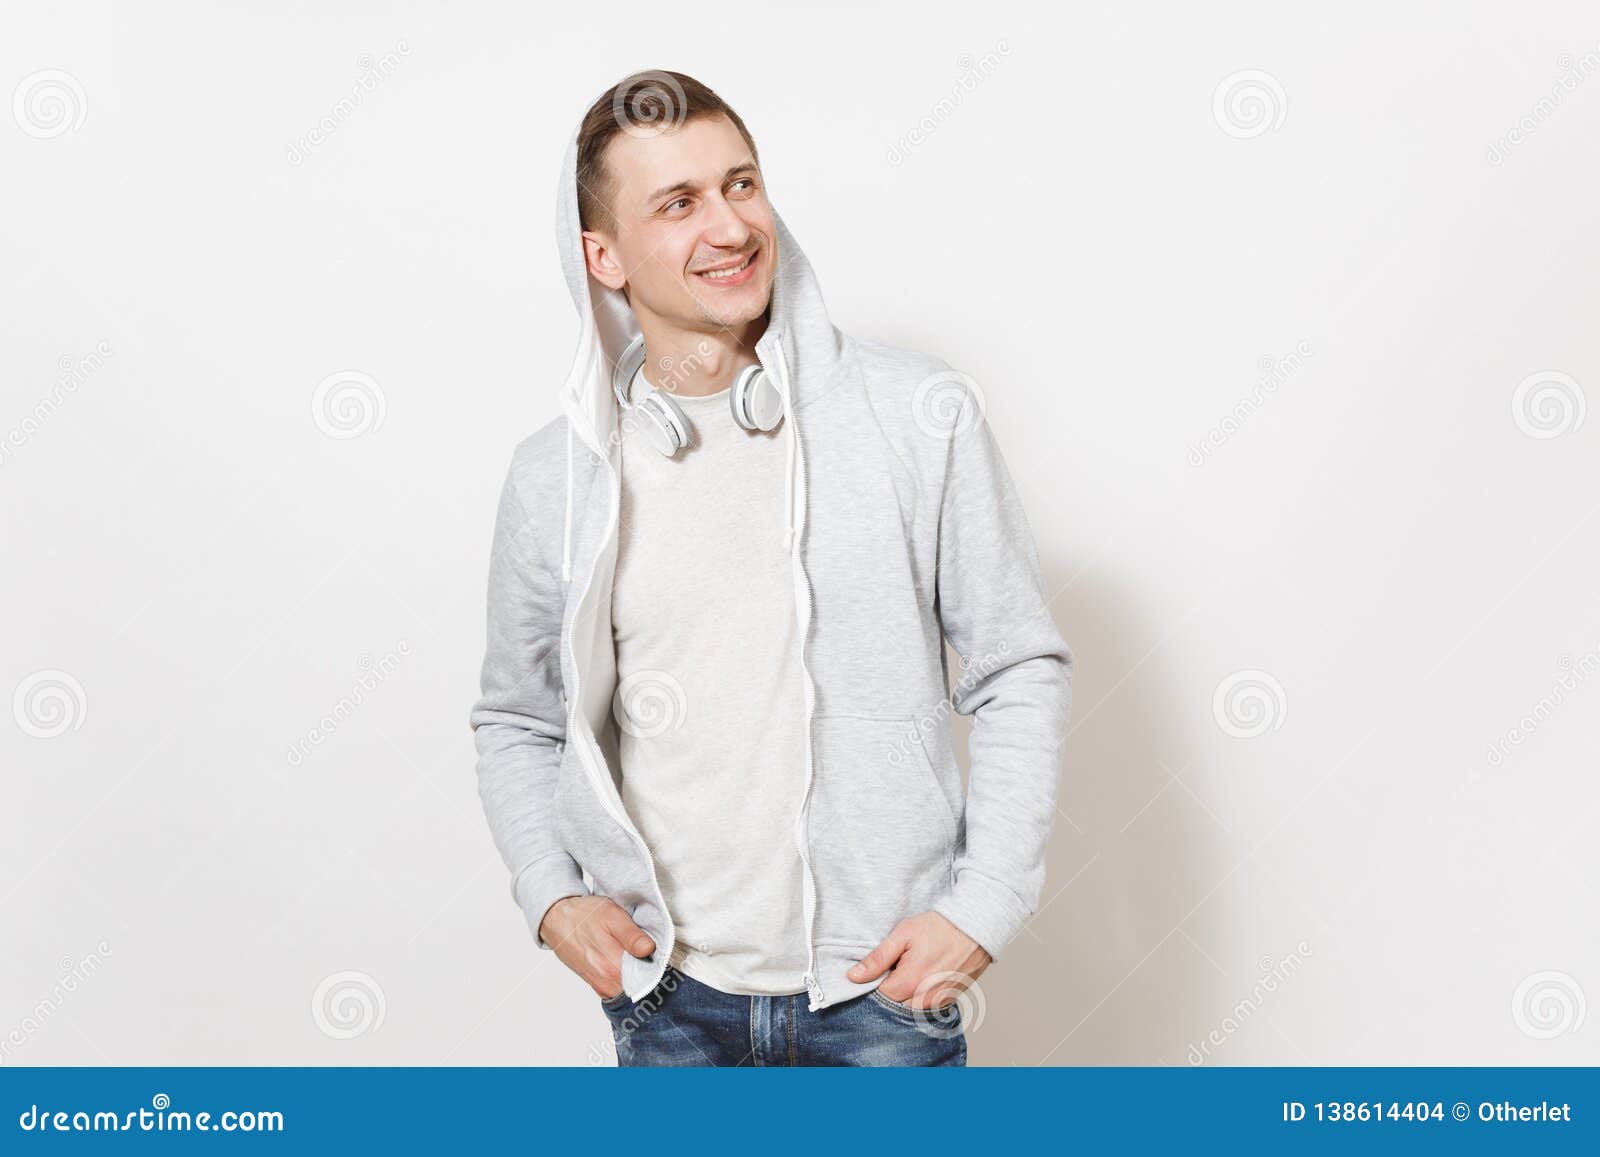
[[934, 390, 1072, 959]]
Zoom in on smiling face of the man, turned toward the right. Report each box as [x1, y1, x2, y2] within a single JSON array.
[[584, 117, 778, 330]]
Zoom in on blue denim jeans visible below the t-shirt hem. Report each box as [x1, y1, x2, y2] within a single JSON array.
[[600, 968, 966, 1066]]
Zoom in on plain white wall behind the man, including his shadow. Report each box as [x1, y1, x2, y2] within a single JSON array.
[[0, 0, 1600, 1064]]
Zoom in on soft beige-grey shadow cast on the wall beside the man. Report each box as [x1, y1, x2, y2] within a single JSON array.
[[955, 557, 1222, 1066]]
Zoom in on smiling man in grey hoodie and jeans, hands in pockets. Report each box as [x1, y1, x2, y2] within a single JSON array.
[[472, 72, 1072, 1064]]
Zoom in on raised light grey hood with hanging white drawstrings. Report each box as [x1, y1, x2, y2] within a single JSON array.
[[555, 117, 842, 581]]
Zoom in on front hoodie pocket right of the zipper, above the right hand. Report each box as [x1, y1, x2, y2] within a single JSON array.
[[806, 714, 955, 947]]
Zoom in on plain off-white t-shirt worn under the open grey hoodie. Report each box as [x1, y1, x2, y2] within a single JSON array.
[[611, 371, 806, 995]]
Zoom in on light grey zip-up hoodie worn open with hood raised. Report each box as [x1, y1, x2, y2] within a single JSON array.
[[470, 117, 1072, 1011]]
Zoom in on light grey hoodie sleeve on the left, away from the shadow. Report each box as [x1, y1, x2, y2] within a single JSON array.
[[470, 451, 589, 949]]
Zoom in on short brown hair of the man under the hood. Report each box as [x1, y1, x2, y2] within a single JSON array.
[[578, 69, 760, 232]]
